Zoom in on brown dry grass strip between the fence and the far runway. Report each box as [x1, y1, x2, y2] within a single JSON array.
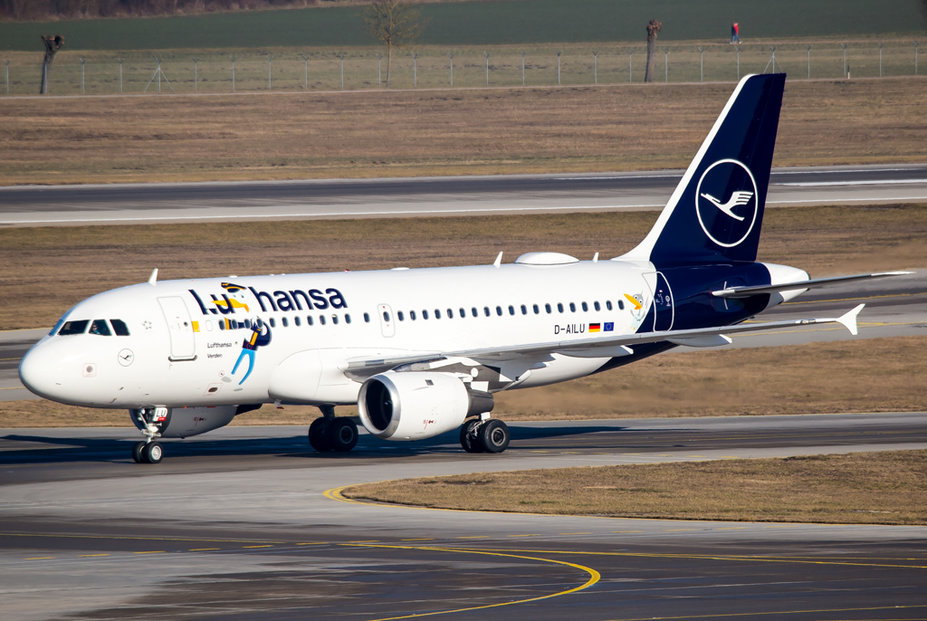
[[0, 76, 927, 185]]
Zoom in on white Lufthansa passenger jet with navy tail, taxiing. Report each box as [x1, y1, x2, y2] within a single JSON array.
[[19, 74, 908, 463]]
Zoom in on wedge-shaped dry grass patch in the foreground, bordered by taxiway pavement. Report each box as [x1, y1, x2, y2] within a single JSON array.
[[342, 451, 927, 524]]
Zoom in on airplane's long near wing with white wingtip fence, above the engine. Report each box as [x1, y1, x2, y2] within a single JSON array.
[[344, 304, 865, 378]]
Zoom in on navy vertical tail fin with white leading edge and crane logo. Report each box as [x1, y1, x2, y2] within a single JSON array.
[[627, 73, 785, 268]]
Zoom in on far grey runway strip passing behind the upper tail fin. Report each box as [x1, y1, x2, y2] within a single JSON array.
[[0, 164, 927, 226]]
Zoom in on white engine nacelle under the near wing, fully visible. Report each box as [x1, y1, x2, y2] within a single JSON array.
[[357, 371, 493, 440]]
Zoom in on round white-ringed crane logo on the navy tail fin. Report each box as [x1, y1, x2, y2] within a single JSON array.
[[695, 159, 758, 248]]
